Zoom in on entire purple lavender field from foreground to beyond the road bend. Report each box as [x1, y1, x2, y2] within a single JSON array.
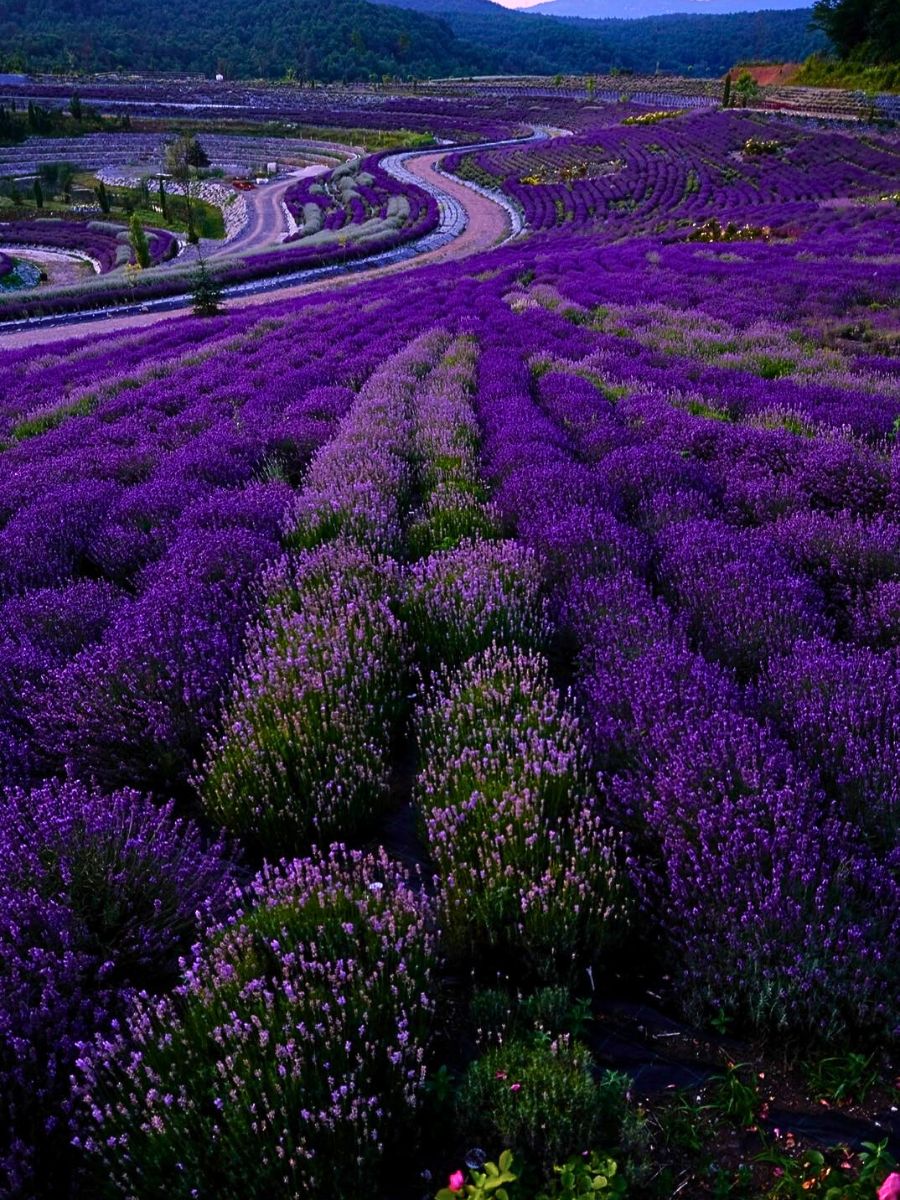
[[0, 97, 900, 1200]]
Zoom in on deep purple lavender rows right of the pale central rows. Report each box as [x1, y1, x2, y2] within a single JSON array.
[[479, 295, 900, 1038]]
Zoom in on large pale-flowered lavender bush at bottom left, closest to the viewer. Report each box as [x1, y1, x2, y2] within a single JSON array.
[[77, 847, 434, 1200]]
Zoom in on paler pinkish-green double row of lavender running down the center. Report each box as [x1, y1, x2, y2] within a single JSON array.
[[68, 316, 626, 1196]]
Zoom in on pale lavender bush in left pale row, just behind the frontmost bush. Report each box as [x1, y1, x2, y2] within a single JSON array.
[[202, 541, 406, 852]]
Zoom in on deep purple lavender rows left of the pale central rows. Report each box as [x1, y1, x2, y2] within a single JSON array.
[[0, 297, 458, 1195]]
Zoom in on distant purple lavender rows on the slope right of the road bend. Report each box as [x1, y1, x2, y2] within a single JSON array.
[[445, 108, 899, 238]]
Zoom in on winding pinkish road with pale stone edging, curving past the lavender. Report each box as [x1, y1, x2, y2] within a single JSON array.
[[0, 136, 554, 352]]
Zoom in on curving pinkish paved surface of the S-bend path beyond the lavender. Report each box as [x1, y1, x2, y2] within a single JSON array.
[[0, 137, 556, 352]]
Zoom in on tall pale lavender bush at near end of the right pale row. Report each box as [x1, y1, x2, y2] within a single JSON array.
[[415, 647, 628, 979]]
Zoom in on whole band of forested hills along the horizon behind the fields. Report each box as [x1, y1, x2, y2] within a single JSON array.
[[0, 0, 828, 82]]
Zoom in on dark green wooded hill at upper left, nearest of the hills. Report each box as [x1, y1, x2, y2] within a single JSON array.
[[0, 0, 496, 82]]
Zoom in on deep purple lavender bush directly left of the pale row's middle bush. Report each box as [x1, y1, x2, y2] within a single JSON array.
[[34, 528, 277, 792]]
